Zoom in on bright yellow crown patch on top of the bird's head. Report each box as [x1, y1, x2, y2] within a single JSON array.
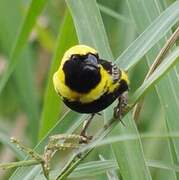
[[61, 44, 97, 67]]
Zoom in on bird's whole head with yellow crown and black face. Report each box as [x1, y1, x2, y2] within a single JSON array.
[[57, 45, 101, 93]]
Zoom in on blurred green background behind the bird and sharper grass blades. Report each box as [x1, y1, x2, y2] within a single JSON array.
[[0, 0, 179, 180]]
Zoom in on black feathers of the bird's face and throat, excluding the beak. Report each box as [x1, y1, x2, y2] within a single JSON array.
[[63, 60, 101, 93]]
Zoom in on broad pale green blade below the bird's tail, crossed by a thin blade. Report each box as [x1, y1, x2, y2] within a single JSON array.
[[112, 113, 152, 180]]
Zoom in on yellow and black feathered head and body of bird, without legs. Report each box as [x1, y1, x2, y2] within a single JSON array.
[[53, 45, 129, 114]]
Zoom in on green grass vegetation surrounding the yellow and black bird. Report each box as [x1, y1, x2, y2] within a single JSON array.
[[0, 0, 179, 180]]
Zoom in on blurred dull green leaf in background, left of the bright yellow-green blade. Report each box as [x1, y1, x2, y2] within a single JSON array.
[[13, 47, 39, 145]]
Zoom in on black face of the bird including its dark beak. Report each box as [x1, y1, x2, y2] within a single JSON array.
[[63, 54, 101, 93]]
